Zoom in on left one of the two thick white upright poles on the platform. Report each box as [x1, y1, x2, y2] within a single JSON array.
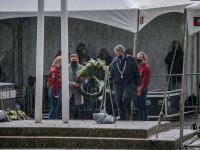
[[35, 0, 44, 122]]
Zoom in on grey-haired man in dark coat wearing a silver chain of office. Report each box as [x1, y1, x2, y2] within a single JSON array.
[[110, 45, 141, 120]]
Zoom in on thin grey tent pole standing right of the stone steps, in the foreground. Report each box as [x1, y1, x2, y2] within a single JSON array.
[[180, 12, 188, 148]]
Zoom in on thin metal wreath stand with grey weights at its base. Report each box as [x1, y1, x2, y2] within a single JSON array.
[[93, 59, 116, 124]]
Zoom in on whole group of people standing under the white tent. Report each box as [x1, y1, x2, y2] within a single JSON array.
[[48, 41, 183, 121]]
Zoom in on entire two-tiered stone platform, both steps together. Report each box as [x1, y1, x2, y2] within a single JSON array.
[[0, 120, 195, 150]]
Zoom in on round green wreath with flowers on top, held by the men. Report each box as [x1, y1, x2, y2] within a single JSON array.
[[76, 58, 106, 98]]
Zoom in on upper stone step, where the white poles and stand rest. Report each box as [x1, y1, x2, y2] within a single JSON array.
[[0, 120, 171, 138]]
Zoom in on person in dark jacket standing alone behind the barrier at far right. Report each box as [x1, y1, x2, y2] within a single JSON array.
[[165, 41, 184, 91]]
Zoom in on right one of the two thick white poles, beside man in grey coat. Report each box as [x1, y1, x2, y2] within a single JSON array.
[[61, 0, 69, 122]]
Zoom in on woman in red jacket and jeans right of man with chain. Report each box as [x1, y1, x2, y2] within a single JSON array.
[[137, 52, 151, 121]]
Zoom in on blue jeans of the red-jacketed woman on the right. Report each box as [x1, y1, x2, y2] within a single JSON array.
[[137, 87, 148, 121]]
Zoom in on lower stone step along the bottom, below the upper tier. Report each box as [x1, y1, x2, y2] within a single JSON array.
[[0, 129, 195, 150]]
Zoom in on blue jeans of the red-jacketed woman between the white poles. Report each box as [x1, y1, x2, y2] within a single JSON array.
[[49, 87, 62, 119]]
